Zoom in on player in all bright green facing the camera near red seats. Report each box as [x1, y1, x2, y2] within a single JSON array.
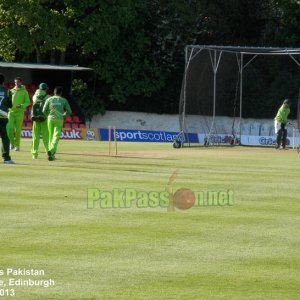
[[7, 77, 30, 151]]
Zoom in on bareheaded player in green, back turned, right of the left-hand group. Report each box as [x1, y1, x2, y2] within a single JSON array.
[[43, 86, 71, 161]]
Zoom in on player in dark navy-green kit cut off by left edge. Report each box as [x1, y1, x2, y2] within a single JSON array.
[[0, 74, 14, 164]]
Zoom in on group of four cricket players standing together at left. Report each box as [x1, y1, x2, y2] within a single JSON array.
[[0, 74, 71, 164]]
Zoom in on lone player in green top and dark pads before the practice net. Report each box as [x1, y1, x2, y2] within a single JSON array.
[[274, 99, 290, 149]]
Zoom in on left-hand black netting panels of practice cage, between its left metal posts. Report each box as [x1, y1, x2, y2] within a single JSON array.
[[180, 50, 240, 138]]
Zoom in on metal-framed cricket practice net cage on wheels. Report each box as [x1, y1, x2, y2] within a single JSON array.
[[177, 45, 300, 148]]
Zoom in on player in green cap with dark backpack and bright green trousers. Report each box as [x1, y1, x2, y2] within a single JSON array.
[[31, 82, 50, 159]]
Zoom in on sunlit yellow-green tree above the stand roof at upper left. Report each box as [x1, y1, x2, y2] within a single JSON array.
[[0, 0, 72, 63]]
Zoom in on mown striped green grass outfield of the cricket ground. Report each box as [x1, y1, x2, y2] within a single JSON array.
[[0, 140, 300, 300]]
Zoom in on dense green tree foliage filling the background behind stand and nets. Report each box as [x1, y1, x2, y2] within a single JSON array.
[[0, 0, 300, 118]]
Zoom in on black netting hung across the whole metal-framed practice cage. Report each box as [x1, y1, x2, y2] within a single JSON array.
[[179, 46, 300, 143]]
